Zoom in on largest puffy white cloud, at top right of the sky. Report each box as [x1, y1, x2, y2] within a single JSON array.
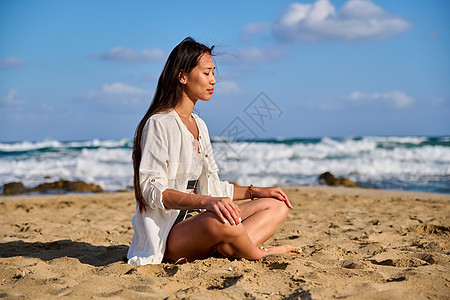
[[273, 0, 411, 42]]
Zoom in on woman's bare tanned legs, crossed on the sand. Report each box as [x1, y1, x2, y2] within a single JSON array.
[[165, 198, 297, 261]]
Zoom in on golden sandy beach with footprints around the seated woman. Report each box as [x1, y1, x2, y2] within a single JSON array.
[[0, 187, 450, 299]]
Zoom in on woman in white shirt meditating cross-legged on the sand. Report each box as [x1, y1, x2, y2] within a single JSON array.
[[127, 38, 299, 266]]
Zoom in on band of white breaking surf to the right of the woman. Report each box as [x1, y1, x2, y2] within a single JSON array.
[[214, 137, 450, 191]]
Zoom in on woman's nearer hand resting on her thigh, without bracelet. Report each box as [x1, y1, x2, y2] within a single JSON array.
[[205, 197, 241, 225]]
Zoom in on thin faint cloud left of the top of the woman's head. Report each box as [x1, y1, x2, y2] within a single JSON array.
[[89, 47, 166, 64]]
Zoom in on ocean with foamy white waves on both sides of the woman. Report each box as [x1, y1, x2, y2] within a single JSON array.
[[0, 136, 450, 193]]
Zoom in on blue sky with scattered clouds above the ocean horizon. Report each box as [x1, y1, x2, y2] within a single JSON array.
[[0, 0, 450, 141]]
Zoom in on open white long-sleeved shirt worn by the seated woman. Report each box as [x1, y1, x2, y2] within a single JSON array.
[[127, 109, 234, 266]]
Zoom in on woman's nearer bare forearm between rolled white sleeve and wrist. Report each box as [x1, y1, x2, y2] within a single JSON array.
[[162, 189, 211, 209]]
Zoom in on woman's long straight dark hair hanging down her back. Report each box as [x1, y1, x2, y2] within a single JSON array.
[[133, 37, 214, 213]]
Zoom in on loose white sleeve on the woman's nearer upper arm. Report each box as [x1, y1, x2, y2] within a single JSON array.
[[139, 117, 169, 210]]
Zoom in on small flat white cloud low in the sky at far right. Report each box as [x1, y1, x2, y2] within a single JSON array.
[[349, 91, 414, 108]]
